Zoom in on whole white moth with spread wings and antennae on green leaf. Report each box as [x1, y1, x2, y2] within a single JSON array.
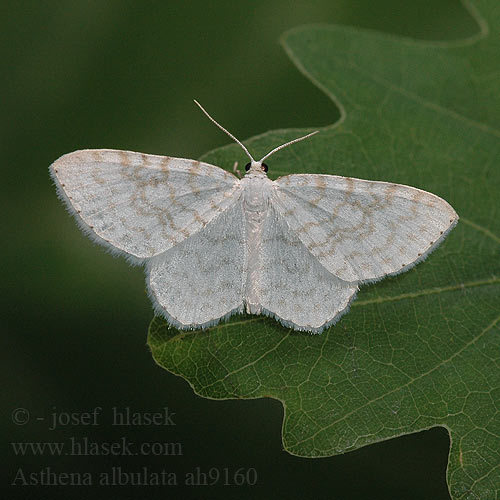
[[50, 101, 458, 333]]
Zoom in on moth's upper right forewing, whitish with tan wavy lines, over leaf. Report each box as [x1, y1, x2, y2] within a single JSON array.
[[275, 174, 458, 282]]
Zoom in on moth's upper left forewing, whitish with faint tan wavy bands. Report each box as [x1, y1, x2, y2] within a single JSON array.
[[50, 149, 240, 259]]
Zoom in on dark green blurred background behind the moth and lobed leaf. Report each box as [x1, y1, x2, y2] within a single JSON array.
[[0, 0, 477, 499]]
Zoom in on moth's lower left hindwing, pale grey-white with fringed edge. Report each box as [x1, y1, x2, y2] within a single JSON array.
[[146, 198, 246, 329]]
